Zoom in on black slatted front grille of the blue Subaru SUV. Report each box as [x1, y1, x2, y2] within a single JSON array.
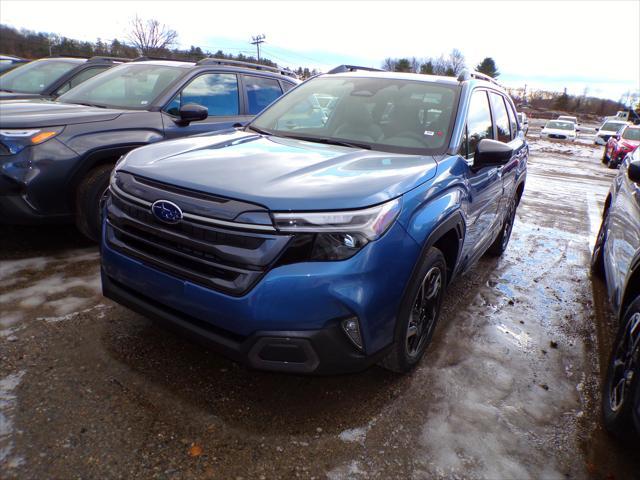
[[106, 171, 292, 295]]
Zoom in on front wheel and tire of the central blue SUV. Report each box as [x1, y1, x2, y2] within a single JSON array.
[[380, 247, 447, 373]]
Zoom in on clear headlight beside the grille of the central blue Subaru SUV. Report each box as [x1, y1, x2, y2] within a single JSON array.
[[273, 198, 402, 260]]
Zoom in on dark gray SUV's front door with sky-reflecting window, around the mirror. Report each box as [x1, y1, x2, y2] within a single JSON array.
[[162, 72, 247, 138]]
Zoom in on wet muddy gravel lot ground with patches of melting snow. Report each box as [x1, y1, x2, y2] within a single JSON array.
[[0, 125, 640, 479]]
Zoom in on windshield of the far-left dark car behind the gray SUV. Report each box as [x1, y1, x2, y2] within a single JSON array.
[[0, 60, 78, 93]]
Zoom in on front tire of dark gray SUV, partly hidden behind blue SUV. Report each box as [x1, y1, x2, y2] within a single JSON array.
[[76, 164, 113, 242]]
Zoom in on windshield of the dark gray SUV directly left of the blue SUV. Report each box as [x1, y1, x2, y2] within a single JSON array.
[[58, 63, 184, 109]]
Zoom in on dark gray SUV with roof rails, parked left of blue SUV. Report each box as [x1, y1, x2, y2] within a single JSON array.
[[0, 58, 299, 239]]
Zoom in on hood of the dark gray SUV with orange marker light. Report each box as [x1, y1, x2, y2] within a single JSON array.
[[0, 100, 123, 128]]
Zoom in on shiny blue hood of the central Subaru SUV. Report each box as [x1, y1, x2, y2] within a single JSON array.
[[117, 131, 437, 211]]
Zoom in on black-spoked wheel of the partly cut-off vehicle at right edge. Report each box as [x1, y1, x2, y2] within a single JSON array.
[[602, 296, 640, 438]]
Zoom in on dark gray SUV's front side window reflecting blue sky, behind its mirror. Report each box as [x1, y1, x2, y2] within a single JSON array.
[[165, 73, 240, 117]]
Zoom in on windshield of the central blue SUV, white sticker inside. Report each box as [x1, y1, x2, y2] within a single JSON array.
[[250, 76, 459, 154]]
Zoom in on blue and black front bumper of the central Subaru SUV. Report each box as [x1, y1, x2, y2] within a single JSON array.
[[102, 222, 420, 374]]
